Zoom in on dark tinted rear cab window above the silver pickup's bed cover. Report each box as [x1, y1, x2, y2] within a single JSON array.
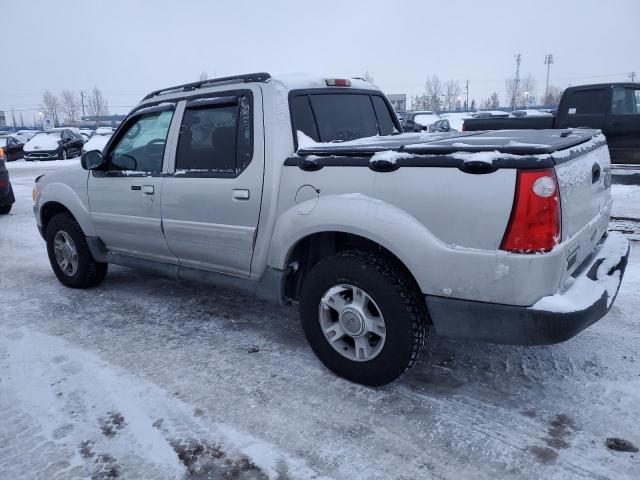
[[291, 93, 395, 142]]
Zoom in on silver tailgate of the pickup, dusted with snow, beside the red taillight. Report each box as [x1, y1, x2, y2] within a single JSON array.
[[552, 135, 612, 274]]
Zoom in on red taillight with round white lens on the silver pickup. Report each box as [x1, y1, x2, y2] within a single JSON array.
[[500, 168, 561, 253]]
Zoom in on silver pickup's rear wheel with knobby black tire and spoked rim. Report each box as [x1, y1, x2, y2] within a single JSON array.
[[300, 250, 429, 386]]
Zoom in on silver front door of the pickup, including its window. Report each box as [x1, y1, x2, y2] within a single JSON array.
[[88, 104, 178, 264]]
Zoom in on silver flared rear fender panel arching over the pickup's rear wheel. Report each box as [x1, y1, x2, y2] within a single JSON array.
[[269, 194, 563, 306]]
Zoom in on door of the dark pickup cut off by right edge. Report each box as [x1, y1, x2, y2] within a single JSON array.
[[604, 86, 640, 164]]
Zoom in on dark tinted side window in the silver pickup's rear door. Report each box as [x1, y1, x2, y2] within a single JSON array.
[[176, 97, 253, 177]]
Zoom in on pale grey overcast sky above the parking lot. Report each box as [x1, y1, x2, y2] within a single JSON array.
[[0, 0, 640, 121]]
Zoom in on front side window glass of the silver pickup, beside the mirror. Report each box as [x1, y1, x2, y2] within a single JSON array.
[[109, 110, 173, 173]]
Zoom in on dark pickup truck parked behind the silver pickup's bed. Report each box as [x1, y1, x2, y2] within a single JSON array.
[[463, 83, 640, 164]]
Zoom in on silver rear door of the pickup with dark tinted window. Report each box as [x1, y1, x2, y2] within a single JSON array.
[[162, 85, 264, 277]]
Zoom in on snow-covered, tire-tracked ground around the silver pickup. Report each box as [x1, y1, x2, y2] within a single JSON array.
[[0, 160, 640, 480]]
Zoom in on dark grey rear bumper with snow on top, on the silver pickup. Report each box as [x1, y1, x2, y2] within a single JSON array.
[[426, 233, 629, 345]]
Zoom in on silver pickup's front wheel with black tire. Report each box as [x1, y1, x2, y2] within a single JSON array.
[[45, 213, 108, 288]]
